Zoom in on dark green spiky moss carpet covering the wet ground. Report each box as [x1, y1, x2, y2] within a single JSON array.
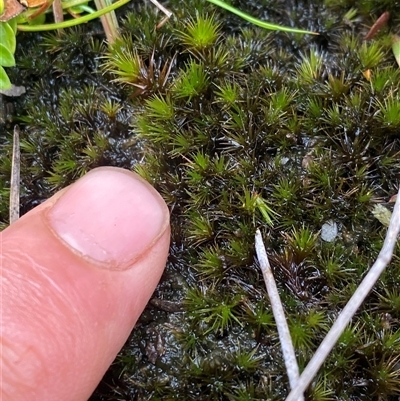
[[0, 0, 400, 401]]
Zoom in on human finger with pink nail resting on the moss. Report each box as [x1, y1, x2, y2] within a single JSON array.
[[0, 168, 170, 401]]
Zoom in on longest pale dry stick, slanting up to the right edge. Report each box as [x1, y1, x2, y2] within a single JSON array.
[[286, 189, 400, 401]]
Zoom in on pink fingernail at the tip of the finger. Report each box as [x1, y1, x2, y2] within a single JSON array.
[[47, 167, 169, 270]]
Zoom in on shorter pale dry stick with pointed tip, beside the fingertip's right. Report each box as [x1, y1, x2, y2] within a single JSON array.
[[255, 230, 303, 401]]
